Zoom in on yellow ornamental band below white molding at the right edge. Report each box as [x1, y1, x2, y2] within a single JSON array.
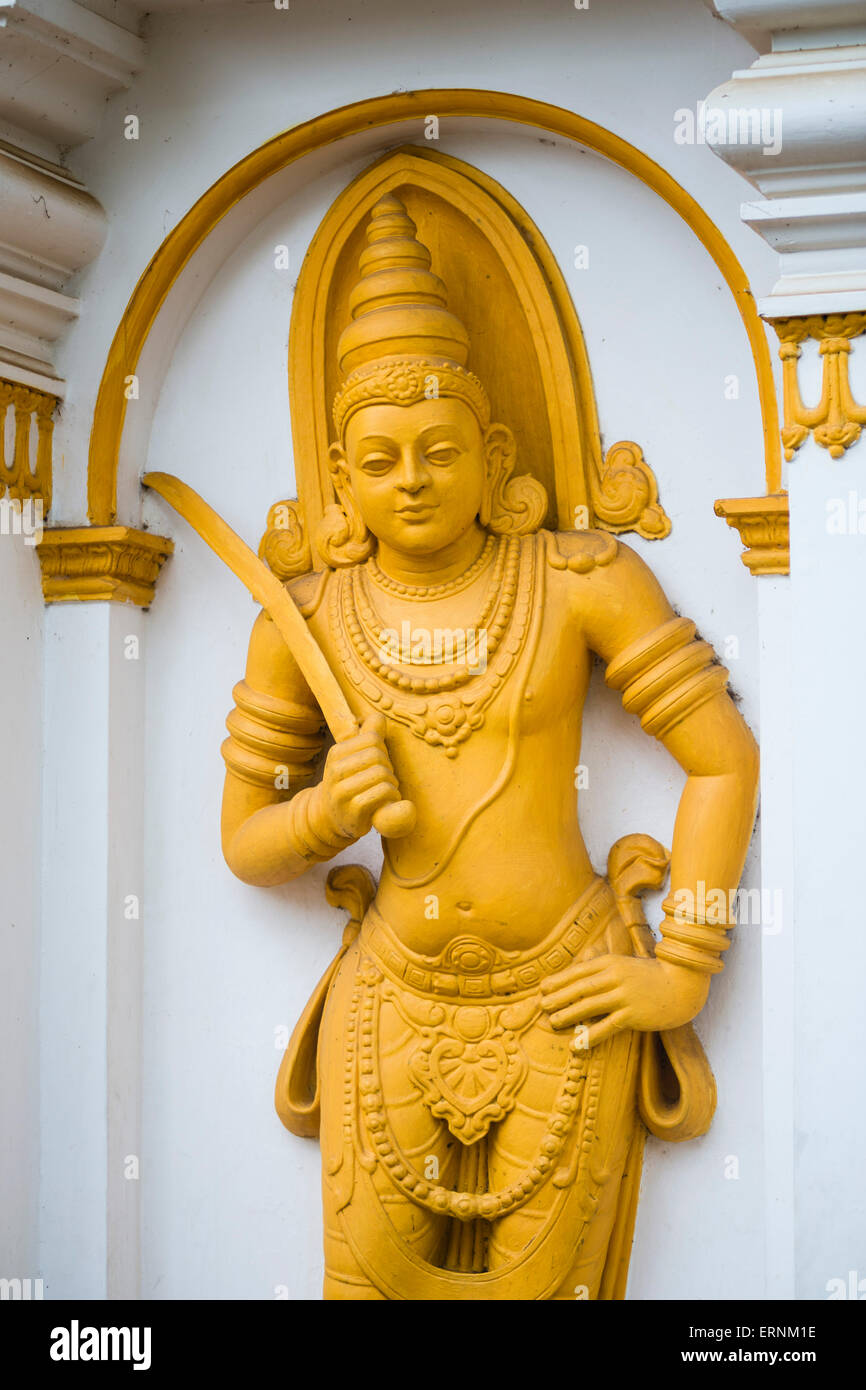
[[770, 310, 866, 459]]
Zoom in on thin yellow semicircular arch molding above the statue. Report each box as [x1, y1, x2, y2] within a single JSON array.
[[88, 88, 781, 525]]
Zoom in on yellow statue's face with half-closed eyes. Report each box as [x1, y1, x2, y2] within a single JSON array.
[[343, 396, 487, 555]]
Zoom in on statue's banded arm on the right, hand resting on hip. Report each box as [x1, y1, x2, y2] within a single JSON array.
[[545, 537, 758, 1045]]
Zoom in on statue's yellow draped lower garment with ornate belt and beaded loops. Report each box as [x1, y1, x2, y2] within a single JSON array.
[[320, 878, 644, 1300]]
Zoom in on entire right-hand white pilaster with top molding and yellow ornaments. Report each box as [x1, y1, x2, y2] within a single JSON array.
[[705, 0, 866, 1298]]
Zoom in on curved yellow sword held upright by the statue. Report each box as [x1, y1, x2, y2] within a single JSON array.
[[142, 473, 416, 840]]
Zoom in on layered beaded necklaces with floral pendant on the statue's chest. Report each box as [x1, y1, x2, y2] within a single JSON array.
[[329, 537, 535, 758]]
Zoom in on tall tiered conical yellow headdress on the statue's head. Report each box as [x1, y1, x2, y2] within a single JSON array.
[[334, 193, 491, 438]]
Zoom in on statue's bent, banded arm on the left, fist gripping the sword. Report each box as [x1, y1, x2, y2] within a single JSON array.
[[222, 613, 399, 887]]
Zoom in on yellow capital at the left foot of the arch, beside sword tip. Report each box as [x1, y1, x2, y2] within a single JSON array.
[[38, 525, 174, 607]]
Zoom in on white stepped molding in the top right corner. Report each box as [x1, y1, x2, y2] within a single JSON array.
[[702, 0, 866, 318]]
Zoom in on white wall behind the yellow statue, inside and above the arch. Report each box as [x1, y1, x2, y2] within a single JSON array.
[[37, 0, 771, 1298]]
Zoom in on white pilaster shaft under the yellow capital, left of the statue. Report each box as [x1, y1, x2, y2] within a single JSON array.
[[40, 603, 146, 1298]]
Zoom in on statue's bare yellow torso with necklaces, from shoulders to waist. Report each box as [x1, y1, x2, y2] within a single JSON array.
[[310, 537, 603, 955]]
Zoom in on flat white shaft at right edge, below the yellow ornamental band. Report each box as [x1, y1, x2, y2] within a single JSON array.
[[790, 338, 866, 1298]]
